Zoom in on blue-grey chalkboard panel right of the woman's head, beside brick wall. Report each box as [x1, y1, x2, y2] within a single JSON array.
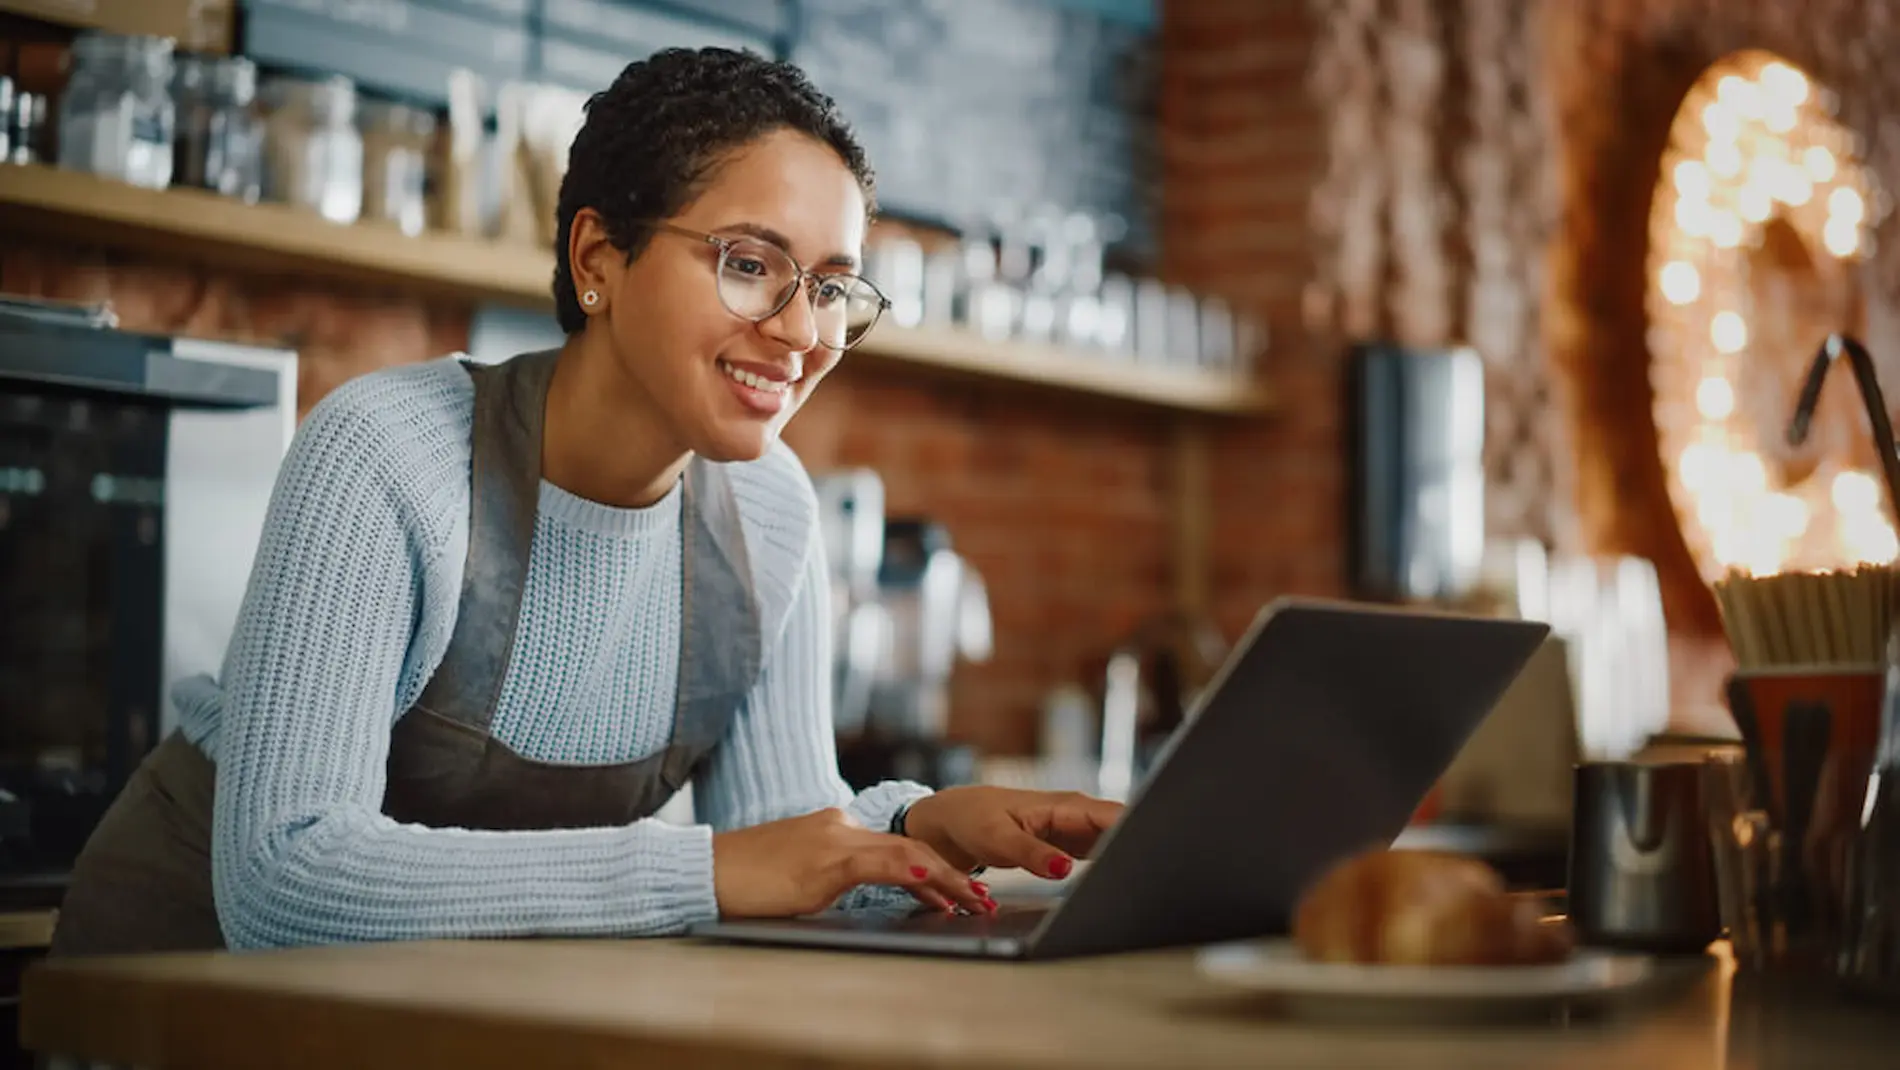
[[790, 0, 1153, 251]]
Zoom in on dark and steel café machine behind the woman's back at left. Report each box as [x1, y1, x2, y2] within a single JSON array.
[[0, 298, 296, 882]]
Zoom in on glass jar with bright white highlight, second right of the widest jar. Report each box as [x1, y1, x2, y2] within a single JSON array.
[[262, 74, 363, 222]]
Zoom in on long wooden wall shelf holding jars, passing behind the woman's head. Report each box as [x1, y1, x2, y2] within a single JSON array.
[[0, 163, 1273, 416]]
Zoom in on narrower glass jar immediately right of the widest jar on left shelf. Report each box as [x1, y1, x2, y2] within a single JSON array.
[[171, 55, 264, 203]]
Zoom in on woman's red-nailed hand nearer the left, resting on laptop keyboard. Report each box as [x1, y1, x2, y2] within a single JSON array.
[[713, 810, 996, 918]]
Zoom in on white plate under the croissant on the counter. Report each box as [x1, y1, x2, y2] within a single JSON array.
[[1197, 939, 1710, 1019]]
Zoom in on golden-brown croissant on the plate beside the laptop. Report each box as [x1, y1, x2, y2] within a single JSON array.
[[1294, 850, 1573, 965]]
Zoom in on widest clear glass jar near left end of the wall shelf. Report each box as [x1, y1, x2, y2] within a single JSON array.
[[57, 32, 177, 190]]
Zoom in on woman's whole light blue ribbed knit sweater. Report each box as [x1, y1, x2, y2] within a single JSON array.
[[175, 357, 925, 948]]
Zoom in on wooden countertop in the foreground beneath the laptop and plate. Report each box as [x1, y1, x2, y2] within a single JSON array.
[[23, 941, 1900, 1070]]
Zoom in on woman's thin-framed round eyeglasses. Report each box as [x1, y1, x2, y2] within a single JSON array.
[[648, 222, 891, 352]]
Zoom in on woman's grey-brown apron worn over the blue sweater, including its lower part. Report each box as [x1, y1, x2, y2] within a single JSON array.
[[51, 352, 762, 956]]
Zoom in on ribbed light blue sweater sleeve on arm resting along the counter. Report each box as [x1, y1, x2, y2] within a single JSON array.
[[198, 388, 716, 948]]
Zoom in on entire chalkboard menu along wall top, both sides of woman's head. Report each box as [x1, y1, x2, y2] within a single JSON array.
[[239, 0, 1155, 255]]
